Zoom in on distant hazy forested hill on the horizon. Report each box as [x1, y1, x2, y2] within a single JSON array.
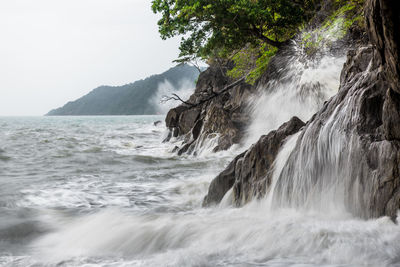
[[46, 65, 199, 116]]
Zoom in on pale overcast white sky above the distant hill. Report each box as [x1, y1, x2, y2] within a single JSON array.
[[0, 0, 180, 116]]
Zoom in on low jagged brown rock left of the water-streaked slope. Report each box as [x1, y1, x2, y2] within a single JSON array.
[[203, 117, 304, 206]]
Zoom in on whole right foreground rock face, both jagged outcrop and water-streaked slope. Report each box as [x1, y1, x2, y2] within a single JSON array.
[[204, 0, 400, 218]]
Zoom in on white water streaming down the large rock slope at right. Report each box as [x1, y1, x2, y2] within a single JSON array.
[[273, 103, 357, 215]]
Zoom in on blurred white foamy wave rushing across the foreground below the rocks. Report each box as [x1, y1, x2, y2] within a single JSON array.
[[34, 207, 400, 266]]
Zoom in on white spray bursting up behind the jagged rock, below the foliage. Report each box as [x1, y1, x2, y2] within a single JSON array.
[[244, 41, 346, 147]]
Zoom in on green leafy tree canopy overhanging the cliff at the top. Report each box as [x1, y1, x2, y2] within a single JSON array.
[[152, 0, 315, 62]]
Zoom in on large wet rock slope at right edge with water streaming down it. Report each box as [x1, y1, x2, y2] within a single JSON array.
[[274, 3, 400, 218]]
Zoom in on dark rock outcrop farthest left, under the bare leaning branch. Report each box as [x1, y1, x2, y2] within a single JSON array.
[[165, 63, 255, 154]]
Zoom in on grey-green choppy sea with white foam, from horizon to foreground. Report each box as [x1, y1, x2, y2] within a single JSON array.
[[0, 116, 400, 267]]
